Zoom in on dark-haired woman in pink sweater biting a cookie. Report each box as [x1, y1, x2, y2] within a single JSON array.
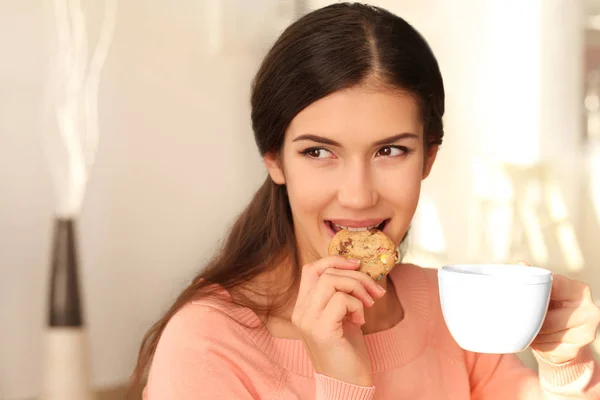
[[133, 4, 600, 400]]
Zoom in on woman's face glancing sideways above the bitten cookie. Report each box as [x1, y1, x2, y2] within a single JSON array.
[[265, 88, 437, 264]]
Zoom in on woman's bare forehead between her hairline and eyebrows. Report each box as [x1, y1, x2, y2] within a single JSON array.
[[287, 88, 423, 141]]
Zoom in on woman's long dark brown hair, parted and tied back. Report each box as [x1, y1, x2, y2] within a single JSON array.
[[130, 3, 444, 395]]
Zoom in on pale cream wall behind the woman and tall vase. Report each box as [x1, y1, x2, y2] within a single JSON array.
[[0, 0, 598, 399]]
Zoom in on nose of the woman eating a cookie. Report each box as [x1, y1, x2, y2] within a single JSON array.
[[338, 162, 379, 210]]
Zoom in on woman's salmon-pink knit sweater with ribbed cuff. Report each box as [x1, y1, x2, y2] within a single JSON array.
[[144, 265, 600, 400]]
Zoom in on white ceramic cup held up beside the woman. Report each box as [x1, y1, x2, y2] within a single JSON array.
[[438, 264, 552, 354]]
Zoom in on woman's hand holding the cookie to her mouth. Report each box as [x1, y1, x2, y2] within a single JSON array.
[[292, 256, 385, 386]]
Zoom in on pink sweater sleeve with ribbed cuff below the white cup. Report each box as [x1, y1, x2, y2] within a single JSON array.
[[466, 347, 600, 400]]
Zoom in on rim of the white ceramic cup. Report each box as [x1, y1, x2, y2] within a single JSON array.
[[438, 263, 553, 285]]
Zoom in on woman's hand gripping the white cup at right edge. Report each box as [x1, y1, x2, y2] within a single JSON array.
[[531, 260, 600, 364]]
